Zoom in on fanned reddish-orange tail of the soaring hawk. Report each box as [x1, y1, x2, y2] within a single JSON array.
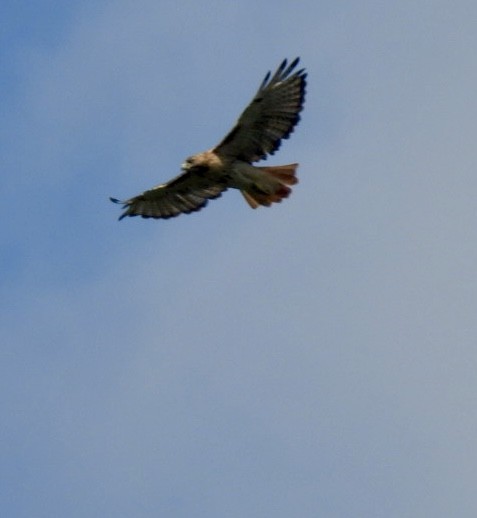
[[240, 164, 298, 209]]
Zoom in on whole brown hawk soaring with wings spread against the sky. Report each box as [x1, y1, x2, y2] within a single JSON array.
[[110, 58, 306, 219]]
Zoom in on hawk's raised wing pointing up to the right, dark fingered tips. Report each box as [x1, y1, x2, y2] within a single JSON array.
[[214, 58, 306, 162]]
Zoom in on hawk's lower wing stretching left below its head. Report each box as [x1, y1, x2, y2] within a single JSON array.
[[110, 171, 227, 220]]
